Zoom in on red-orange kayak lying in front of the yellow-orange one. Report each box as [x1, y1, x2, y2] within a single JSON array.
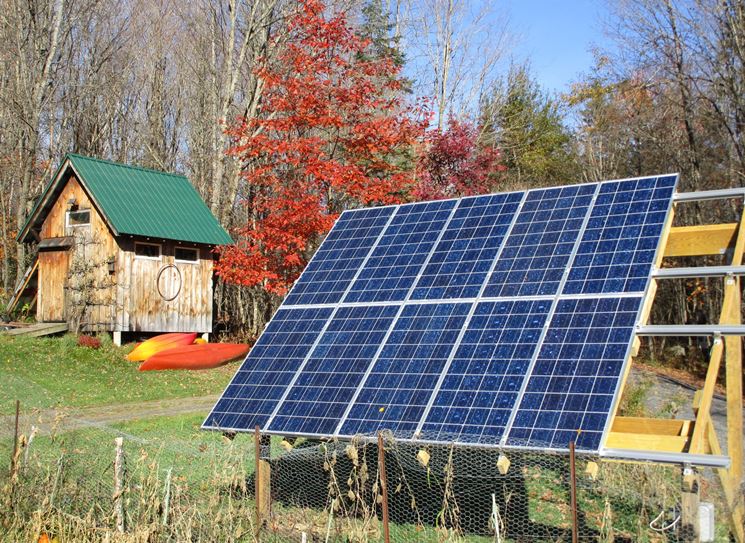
[[140, 343, 248, 371]]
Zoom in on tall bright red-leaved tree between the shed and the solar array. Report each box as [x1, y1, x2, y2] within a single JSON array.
[[216, 0, 426, 295]]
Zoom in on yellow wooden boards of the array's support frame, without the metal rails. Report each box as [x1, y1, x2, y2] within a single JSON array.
[[605, 205, 745, 543]]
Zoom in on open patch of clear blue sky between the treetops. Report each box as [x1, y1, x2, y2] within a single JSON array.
[[503, 0, 612, 92]]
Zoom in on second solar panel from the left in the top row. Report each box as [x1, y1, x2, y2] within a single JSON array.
[[344, 200, 456, 302]]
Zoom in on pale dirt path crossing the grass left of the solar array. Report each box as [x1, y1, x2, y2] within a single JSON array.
[[0, 395, 218, 438]]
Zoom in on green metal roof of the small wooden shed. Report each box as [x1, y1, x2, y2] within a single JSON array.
[[19, 154, 232, 245]]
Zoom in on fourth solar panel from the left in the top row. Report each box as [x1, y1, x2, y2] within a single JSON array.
[[484, 184, 597, 296]]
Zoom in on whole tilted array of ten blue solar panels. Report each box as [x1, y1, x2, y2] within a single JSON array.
[[204, 175, 677, 451]]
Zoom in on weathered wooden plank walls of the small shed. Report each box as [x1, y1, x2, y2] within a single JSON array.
[[37, 177, 213, 333]]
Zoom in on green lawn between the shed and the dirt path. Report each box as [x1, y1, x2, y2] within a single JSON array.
[[0, 335, 236, 414]]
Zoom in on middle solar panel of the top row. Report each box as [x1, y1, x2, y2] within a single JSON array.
[[412, 192, 524, 300]]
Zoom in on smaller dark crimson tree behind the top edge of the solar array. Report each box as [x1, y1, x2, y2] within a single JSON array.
[[412, 117, 506, 200]]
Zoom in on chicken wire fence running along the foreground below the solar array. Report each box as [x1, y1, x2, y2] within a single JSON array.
[[0, 412, 728, 542]]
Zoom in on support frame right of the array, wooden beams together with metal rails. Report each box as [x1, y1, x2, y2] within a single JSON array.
[[605, 189, 745, 543]]
